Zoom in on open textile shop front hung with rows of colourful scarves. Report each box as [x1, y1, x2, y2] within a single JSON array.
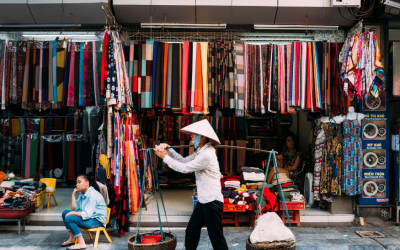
[[0, 0, 392, 231]]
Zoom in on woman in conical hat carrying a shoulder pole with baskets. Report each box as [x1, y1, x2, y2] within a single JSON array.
[[155, 119, 228, 250]]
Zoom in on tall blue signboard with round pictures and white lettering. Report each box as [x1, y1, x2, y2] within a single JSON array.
[[358, 91, 389, 205]]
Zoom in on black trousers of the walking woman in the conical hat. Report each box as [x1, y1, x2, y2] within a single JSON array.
[[185, 201, 228, 250]]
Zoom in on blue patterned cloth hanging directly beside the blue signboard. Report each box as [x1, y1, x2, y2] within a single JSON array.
[[341, 119, 363, 196]]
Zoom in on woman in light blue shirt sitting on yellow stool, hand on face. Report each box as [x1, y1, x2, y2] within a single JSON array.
[[61, 174, 107, 249]]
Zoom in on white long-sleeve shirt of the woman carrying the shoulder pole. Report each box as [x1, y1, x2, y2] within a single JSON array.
[[163, 143, 224, 204]]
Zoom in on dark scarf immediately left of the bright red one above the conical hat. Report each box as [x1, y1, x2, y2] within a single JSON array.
[[171, 43, 182, 113]]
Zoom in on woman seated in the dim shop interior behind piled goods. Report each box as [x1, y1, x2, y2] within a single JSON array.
[[267, 135, 301, 184]]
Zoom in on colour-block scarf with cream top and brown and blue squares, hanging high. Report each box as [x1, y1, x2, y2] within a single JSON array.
[[141, 41, 154, 109]]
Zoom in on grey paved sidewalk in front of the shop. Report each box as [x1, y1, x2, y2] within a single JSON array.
[[0, 226, 400, 250]]
